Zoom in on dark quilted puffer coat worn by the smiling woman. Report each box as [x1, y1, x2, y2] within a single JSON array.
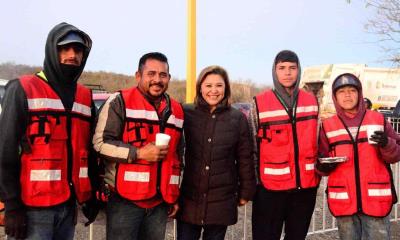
[[179, 105, 255, 225]]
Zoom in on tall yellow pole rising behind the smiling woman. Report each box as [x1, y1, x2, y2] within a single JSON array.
[[186, 0, 196, 103]]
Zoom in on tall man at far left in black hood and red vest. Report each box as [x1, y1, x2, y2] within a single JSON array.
[[0, 23, 98, 239]]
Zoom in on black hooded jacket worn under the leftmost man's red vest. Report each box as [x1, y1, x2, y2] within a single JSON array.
[[0, 23, 98, 211]]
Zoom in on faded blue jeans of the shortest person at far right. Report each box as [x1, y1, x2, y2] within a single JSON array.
[[336, 213, 390, 240]]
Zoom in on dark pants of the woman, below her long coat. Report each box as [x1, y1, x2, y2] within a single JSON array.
[[178, 221, 228, 240]]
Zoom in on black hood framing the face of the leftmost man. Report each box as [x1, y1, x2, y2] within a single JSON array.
[[43, 23, 92, 108]]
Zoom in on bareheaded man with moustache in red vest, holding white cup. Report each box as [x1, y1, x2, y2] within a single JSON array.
[[93, 52, 183, 240]]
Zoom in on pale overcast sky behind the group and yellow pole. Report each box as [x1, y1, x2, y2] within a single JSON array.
[[0, 0, 391, 85]]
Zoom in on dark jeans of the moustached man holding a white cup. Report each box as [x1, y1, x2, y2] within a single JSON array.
[[106, 193, 168, 240]]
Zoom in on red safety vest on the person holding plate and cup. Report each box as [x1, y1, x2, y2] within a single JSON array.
[[323, 110, 395, 217]]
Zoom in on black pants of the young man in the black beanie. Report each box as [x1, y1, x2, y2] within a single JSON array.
[[252, 185, 317, 240]]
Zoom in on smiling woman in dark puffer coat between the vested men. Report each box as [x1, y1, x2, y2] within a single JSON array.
[[178, 66, 255, 240]]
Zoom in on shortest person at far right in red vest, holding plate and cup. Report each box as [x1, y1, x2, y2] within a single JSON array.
[[317, 73, 400, 240]]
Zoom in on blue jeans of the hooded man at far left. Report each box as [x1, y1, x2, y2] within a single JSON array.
[[7, 202, 76, 240]]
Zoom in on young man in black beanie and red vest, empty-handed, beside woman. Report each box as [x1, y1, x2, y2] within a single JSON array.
[[252, 50, 320, 240]]
